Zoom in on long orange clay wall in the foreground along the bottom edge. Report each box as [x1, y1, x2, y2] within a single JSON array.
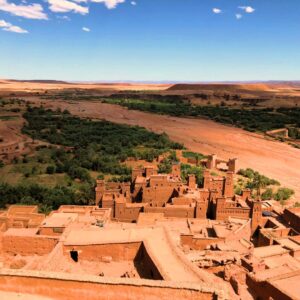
[[0, 270, 216, 300]]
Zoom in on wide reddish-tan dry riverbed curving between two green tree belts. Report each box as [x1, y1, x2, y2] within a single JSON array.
[[31, 100, 300, 201]]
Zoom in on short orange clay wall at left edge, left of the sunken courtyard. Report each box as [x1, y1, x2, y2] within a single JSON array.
[[2, 235, 58, 256]]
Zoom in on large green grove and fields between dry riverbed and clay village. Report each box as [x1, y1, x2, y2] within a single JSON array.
[[0, 107, 183, 211]]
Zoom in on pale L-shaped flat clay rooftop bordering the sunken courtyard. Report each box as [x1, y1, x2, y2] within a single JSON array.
[[64, 227, 209, 282]]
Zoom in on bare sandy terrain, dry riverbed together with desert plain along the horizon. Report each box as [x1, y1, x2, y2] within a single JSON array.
[[0, 81, 300, 195]]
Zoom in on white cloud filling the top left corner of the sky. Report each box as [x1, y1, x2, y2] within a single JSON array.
[[0, 0, 48, 20]]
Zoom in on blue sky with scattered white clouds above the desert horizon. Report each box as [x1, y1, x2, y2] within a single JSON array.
[[0, 0, 300, 81]]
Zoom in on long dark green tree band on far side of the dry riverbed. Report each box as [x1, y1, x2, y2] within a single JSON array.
[[103, 98, 300, 132]]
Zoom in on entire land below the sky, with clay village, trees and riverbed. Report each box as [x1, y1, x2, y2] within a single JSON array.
[[0, 80, 300, 300]]
